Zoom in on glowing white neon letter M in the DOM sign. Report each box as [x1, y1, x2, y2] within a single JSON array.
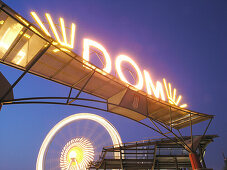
[[144, 70, 165, 101]]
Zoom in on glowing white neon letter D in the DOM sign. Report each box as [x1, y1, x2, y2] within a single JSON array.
[[83, 39, 111, 73]]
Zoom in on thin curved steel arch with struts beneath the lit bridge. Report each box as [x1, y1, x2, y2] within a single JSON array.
[[1, 93, 212, 152]]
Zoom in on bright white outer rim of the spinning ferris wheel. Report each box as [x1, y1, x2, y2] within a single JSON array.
[[36, 113, 122, 170]]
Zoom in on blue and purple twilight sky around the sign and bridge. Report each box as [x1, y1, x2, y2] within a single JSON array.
[[0, 0, 227, 170]]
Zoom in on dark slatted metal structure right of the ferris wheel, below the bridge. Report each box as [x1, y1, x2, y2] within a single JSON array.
[[91, 135, 217, 170]]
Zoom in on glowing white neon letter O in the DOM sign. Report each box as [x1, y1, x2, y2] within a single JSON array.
[[115, 55, 143, 90]]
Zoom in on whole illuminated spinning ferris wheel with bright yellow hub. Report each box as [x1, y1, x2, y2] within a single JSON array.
[[36, 113, 122, 170]]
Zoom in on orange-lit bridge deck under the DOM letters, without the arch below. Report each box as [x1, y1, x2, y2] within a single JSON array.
[[0, 2, 213, 129]]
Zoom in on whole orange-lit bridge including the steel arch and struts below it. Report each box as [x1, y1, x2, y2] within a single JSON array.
[[0, 2, 214, 169]]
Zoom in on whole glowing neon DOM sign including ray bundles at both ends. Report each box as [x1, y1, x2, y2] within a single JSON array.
[[31, 12, 187, 108]]
